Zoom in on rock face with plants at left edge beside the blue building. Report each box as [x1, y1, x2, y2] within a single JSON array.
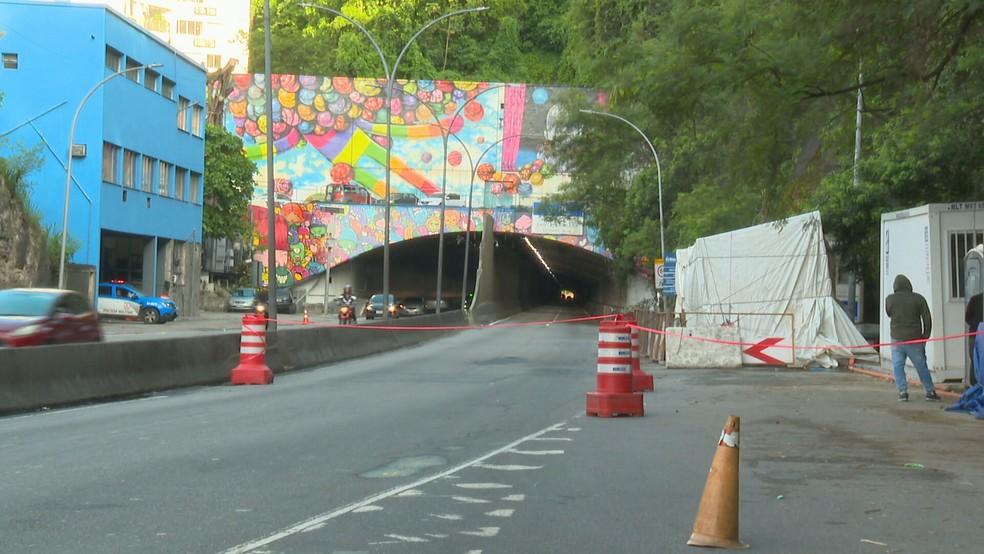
[[0, 181, 51, 289]]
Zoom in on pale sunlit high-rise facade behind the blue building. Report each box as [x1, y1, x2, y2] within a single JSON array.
[[60, 0, 250, 72]]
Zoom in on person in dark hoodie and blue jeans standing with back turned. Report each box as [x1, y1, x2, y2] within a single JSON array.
[[885, 275, 940, 402]]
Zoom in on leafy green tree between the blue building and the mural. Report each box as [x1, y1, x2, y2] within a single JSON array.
[[202, 125, 256, 239]]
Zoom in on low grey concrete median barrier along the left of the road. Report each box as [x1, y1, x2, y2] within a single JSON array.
[[0, 311, 476, 413]]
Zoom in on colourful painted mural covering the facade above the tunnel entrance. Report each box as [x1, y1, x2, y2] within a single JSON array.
[[225, 74, 610, 284]]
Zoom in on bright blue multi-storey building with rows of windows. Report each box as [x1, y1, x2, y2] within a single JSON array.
[[0, 0, 205, 307]]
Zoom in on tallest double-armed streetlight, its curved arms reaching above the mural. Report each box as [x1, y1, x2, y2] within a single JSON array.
[[300, 0, 489, 319]]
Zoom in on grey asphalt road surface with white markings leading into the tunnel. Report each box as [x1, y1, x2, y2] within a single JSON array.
[[0, 309, 984, 553]]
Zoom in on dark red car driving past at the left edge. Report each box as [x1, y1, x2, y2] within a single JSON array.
[[0, 289, 102, 348]]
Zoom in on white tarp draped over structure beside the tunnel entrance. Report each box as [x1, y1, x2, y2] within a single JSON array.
[[676, 212, 872, 367]]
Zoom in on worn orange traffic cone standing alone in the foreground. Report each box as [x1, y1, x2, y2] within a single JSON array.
[[687, 415, 748, 549]]
